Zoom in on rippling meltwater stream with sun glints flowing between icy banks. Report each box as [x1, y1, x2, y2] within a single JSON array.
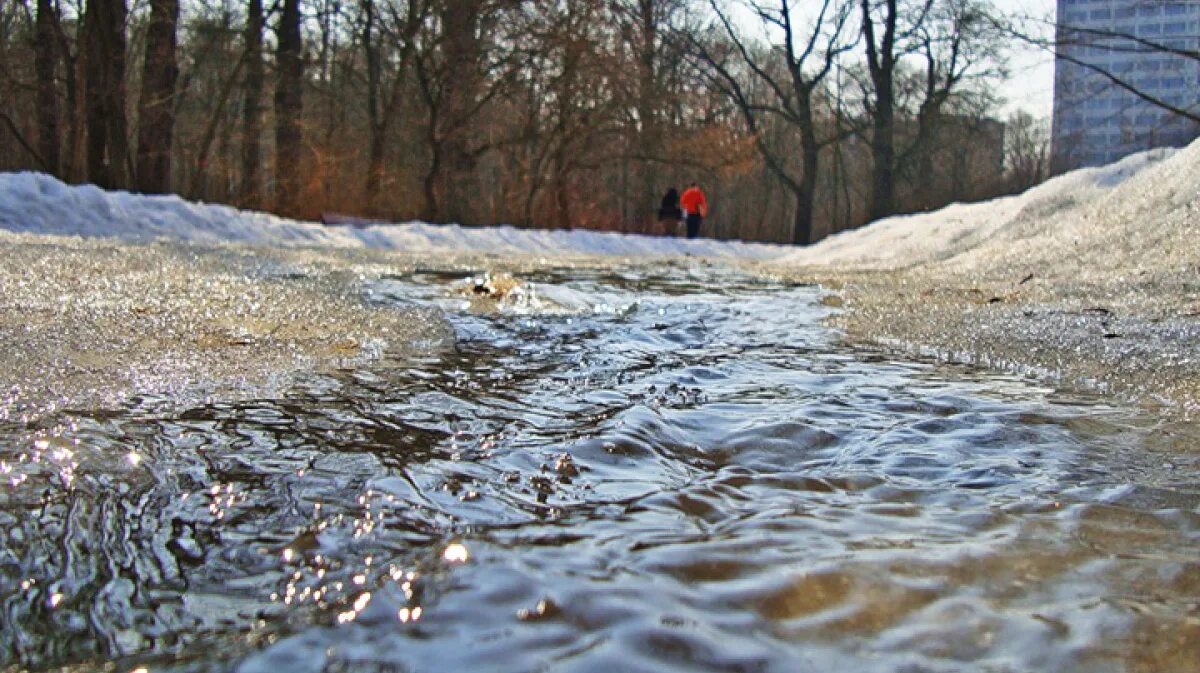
[[0, 266, 1200, 673]]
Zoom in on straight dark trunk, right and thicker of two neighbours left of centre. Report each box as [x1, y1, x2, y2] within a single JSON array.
[[275, 0, 304, 215]]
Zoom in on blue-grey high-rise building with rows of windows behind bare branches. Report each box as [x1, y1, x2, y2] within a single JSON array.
[[1051, 0, 1200, 173]]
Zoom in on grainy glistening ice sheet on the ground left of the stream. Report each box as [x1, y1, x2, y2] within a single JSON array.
[[0, 230, 454, 422]]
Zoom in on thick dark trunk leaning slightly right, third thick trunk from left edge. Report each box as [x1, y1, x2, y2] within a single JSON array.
[[137, 0, 179, 194]]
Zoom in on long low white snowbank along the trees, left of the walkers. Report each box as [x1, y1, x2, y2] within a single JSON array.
[[0, 173, 790, 259]]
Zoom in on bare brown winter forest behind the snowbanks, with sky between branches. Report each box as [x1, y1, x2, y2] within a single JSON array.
[[0, 0, 1048, 245]]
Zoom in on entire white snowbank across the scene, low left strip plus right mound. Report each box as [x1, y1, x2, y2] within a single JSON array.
[[0, 133, 1200, 272]]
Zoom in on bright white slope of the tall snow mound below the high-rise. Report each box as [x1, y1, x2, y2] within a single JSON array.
[[778, 144, 1180, 270]]
